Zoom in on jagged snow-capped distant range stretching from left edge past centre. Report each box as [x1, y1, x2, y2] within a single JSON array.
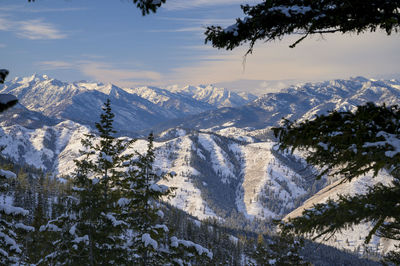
[[0, 75, 255, 132]]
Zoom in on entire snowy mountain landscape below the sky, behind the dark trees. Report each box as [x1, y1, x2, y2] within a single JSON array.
[[0, 75, 400, 256]]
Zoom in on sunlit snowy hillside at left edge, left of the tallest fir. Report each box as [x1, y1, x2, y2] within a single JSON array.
[[0, 121, 89, 174]]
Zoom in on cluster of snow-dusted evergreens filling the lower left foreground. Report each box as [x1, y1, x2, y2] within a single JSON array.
[[0, 98, 212, 265]]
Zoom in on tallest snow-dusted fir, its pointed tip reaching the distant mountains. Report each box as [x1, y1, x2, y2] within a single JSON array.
[[41, 100, 133, 265]]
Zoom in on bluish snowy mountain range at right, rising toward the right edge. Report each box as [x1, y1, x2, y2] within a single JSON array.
[[152, 77, 400, 131]]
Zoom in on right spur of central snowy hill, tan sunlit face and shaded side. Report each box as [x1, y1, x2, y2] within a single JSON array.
[[238, 142, 307, 218]]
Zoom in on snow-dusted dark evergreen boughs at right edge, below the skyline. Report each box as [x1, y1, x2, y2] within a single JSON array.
[[274, 103, 400, 264]]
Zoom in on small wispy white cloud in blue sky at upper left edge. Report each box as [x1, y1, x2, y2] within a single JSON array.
[[0, 17, 67, 40]]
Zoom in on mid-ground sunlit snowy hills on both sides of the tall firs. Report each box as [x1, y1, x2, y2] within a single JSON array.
[[0, 121, 323, 222]]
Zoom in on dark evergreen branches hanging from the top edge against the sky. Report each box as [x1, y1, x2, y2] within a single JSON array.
[[125, 0, 400, 53]]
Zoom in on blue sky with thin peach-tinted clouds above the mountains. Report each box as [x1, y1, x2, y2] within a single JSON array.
[[0, 0, 400, 94]]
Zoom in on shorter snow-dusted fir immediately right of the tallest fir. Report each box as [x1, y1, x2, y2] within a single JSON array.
[[118, 134, 212, 265]]
